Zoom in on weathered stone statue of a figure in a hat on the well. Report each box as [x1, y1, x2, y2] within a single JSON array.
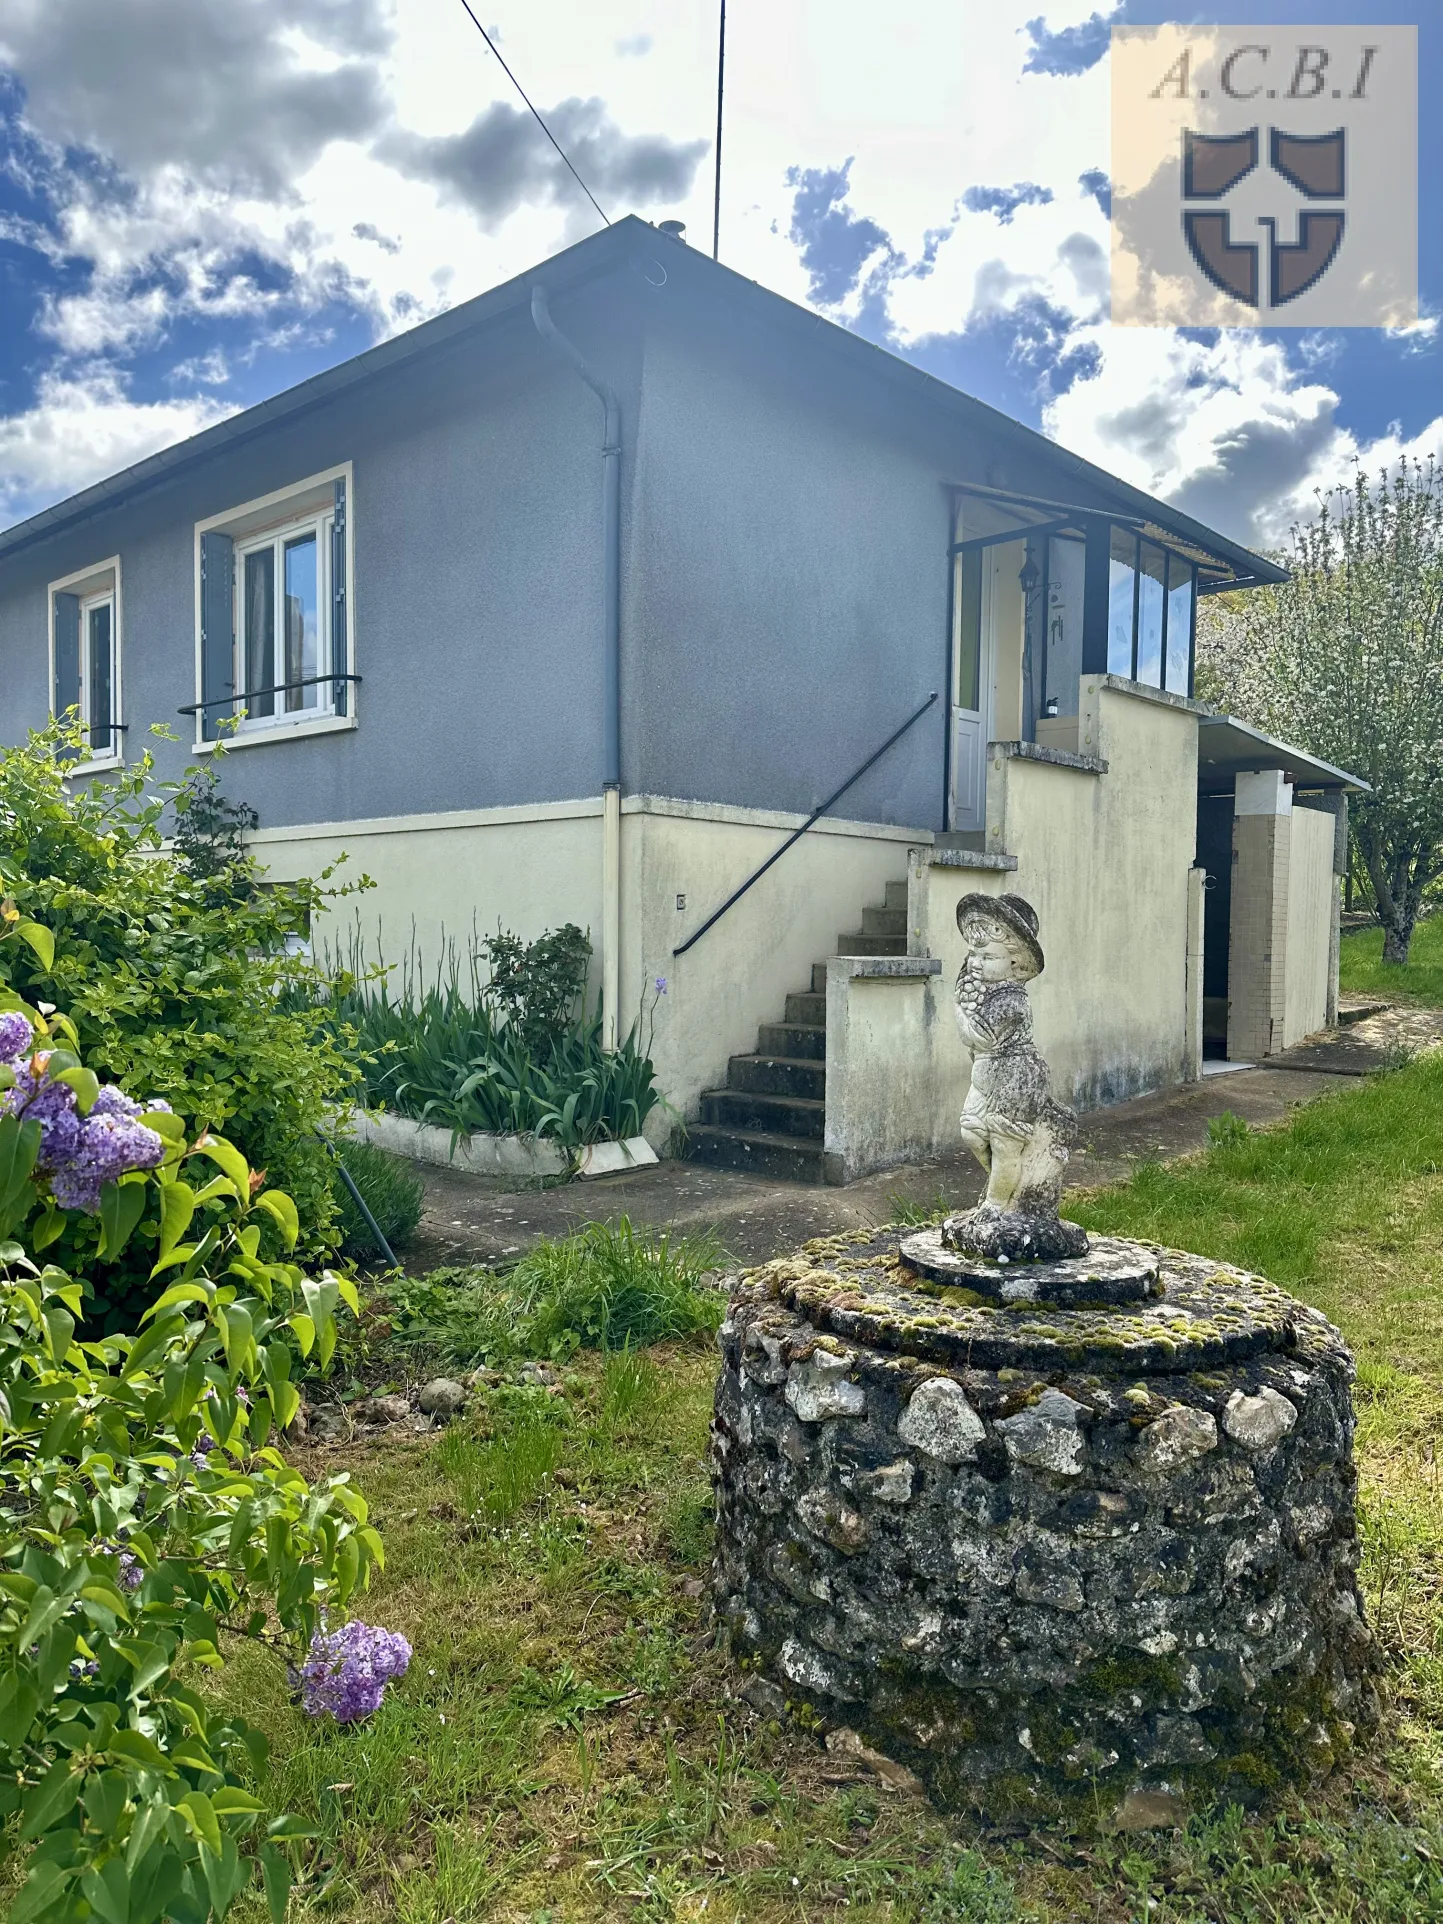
[[943, 895, 1087, 1262]]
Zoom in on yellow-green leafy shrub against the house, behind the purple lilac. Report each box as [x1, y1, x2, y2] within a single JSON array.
[[0, 725, 358, 1297]]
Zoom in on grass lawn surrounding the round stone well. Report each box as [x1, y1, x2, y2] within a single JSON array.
[[219, 1056, 1443, 1924]]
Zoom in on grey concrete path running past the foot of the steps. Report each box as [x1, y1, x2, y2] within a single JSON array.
[[406, 1008, 1443, 1272]]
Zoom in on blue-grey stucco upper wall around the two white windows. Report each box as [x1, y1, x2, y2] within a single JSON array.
[[0, 290, 635, 827]]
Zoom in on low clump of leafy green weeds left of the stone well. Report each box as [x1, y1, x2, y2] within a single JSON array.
[[385, 1216, 725, 1364]]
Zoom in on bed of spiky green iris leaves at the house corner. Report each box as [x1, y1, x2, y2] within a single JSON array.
[[315, 924, 660, 1149]]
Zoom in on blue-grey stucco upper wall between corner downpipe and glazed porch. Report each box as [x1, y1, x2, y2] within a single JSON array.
[[623, 300, 962, 827]]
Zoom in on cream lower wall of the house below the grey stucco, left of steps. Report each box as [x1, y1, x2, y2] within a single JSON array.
[[252, 797, 929, 1147]]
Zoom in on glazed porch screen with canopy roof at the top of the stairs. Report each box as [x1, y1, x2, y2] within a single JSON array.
[[952, 481, 1287, 714]]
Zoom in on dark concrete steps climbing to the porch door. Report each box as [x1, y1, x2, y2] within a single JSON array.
[[687, 881, 906, 1183]]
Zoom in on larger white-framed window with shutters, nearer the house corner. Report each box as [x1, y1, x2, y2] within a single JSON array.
[[187, 468, 358, 747]]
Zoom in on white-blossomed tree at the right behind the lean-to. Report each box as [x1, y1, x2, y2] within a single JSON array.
[[1199, 460, 1443, 964]]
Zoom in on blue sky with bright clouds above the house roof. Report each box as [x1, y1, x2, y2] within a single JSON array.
[[0, 0, 1443, 546]]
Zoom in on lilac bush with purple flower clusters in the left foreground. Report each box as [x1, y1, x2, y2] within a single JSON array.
[[0, 950, 410, 1924]]
